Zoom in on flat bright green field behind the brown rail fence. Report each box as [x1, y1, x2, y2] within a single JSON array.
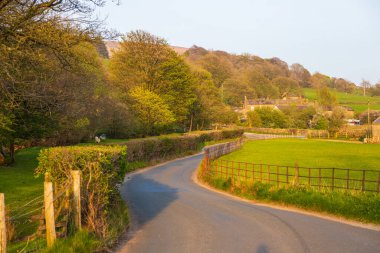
[[213, 139, 380, 191]]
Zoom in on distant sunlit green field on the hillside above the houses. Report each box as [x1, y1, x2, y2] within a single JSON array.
[[303, 88, 380, 113]]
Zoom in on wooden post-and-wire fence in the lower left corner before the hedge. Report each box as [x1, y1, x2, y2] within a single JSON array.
[[0, 171, 81, 253]]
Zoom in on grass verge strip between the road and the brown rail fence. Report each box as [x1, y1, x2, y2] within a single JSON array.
[[202, 178, 380, 224]]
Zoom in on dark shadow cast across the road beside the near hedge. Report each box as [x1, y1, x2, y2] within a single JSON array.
[[120, 174, 178, 227]]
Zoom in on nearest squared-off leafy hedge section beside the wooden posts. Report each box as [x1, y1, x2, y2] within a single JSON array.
[[35, 146, 127, 238]]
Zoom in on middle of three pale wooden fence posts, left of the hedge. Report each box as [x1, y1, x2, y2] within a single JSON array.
[[44, 181, 57, 247]]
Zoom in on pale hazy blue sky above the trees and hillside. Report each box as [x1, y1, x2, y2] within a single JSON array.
[[99, 0, 380, 83]]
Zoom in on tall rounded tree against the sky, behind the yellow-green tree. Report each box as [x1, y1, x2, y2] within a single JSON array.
[[109, 31, 196, 127]]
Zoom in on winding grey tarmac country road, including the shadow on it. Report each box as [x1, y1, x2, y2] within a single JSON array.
[[116, 155, 380, 253]]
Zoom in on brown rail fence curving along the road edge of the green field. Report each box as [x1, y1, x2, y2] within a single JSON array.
[[203, 140, 380, 193]]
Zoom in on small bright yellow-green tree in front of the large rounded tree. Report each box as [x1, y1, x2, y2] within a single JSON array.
[[129, 87, 175, 135]]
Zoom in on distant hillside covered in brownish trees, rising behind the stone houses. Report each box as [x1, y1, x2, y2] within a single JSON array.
[[99, 41, 380, 110]]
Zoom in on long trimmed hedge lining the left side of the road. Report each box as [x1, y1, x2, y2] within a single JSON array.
[[36, 130, 244, 244]]
